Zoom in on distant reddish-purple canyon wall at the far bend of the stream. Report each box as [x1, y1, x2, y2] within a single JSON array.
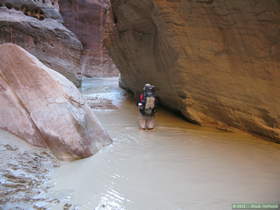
[[59, 0, 118, 77]]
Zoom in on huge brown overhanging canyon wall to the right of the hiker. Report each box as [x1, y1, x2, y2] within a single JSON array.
[[107, 0, 280, 142]]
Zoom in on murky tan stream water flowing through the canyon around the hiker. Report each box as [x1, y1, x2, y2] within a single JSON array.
[[50, 78, 280, 210]]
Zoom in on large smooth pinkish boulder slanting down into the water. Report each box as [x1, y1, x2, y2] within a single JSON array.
[[0, 44, 111, 160]]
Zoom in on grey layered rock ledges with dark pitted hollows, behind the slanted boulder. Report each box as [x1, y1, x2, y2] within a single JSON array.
[[0, 0, 82, 86]]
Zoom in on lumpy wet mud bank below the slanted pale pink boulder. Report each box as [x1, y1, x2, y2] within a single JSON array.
[[0, 129, 77, 210]]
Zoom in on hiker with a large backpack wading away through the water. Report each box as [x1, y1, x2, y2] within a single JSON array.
[[137, 84, 156, 130]]
